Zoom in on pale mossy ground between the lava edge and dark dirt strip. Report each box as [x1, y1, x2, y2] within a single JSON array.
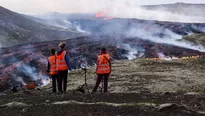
[[64, 57, 205, 93]]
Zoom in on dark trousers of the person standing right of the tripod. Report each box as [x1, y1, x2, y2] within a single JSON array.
[[93, 73, 110, 92]]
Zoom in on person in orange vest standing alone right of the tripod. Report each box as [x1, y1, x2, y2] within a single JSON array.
[[92, 48, 111, 93]]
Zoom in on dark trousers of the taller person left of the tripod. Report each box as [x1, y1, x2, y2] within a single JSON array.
[[58, 70, 68, 93]]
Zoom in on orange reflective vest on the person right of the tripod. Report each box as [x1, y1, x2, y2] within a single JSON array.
[[97, 54, 110, 74]]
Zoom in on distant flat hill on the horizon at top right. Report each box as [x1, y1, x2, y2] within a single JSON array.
[[142, 2, 205, 16]]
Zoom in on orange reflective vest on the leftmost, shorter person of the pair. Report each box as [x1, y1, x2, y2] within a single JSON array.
[[48, 56, 56, 75]]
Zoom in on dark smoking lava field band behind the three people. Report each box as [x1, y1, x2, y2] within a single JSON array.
[[0, 36, 204, 91]]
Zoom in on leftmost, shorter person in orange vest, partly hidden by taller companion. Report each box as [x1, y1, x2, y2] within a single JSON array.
[[47, 49, 58, 93]]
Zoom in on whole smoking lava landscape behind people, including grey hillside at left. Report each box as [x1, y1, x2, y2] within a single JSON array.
[[0, 3, 205, 91]]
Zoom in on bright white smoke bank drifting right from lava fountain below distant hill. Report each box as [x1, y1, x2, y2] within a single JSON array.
[[108, 4, 205, 23]]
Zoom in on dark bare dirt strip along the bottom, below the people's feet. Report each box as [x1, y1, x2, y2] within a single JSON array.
[[0, 91, 204, 116]]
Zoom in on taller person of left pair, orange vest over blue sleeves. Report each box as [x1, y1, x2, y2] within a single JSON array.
[[56, 42, 72, 93]]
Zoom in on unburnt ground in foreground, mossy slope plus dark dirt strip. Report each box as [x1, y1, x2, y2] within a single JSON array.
[[0, 57, 205, 116]]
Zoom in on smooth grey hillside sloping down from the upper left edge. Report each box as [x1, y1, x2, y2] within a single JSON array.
[[0, 6, 80, 47]]
